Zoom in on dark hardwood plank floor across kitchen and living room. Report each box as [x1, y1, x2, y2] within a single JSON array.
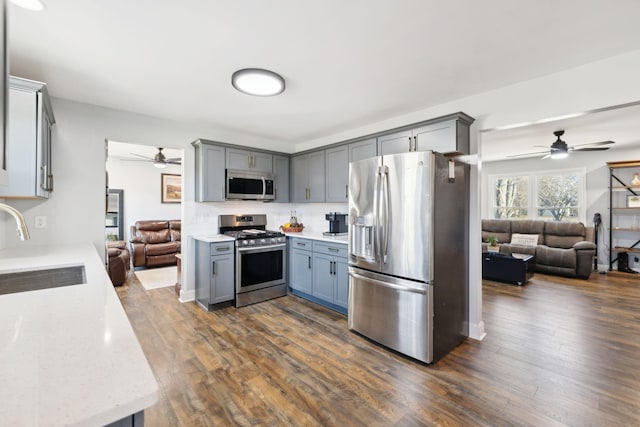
[[117, 274, 640, 426]]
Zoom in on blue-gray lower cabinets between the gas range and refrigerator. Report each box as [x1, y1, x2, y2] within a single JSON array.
[[289, 238, 349, 314]]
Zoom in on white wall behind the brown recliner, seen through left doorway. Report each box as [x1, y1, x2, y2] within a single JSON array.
[[107, 158, 182, 240]]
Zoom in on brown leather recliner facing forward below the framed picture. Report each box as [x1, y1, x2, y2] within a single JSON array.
[[131, 220, 181, 267]]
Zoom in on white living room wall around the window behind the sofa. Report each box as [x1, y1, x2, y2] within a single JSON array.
[[480, 147, 640, 271]]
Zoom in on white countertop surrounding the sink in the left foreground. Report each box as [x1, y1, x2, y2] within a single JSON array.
[[0, 243, 158, 426]]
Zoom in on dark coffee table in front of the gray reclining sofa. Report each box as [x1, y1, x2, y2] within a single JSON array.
[[482, 252, 536, 285]]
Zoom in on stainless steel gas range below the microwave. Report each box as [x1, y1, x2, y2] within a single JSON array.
[[218, 215, 287, 307]]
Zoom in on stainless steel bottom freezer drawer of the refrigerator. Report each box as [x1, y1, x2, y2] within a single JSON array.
[[348, 267, 433, 363]]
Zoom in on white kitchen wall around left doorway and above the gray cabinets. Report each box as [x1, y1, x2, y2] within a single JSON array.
[[5, 47, 640, 338]]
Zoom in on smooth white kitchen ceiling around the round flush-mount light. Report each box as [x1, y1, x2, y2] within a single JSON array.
[[9, 0, 640, 151]]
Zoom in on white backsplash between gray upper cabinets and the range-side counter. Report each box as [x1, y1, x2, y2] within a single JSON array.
[[190, 200, 349, 234]]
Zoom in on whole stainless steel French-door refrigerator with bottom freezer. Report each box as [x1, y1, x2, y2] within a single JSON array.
[[348, 151, 469, 363]]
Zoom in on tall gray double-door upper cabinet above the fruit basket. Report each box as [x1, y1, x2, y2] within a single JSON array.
[[290, 150, 325, 203]]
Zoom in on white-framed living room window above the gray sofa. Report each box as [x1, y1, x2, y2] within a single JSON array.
[[489, 168, 586, 222]]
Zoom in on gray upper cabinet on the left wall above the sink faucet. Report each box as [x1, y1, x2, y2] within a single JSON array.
[[0, 77, 55, 198]]
